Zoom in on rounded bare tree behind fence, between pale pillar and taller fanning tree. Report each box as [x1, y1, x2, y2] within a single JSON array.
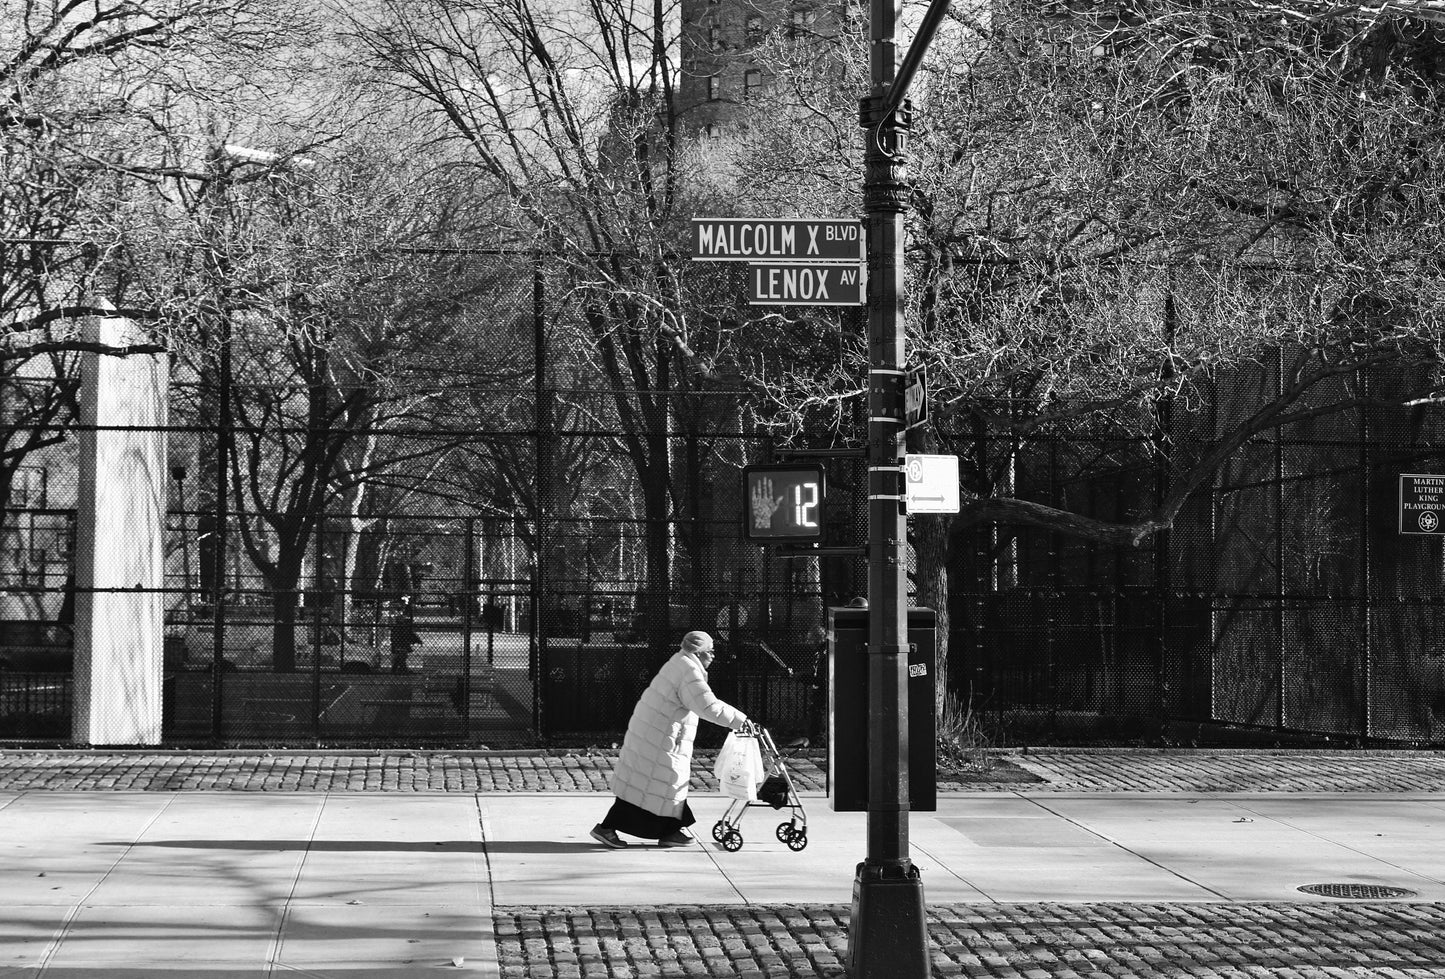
[[143, 133, 514, 671]]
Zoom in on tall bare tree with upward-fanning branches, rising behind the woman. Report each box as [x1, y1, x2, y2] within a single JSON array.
[[353, 0, 745, 658]]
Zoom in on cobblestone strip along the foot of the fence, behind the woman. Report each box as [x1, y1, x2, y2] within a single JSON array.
[[0, 748, 1445, 797]]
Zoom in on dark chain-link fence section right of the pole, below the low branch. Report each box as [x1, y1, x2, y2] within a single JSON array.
[[951, 352, 1445, 744]]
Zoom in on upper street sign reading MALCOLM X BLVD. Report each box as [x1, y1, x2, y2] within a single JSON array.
[[692, 218, 864, 264]]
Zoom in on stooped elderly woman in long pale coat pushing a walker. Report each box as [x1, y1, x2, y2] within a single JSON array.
[[592, 632, 749, 849]]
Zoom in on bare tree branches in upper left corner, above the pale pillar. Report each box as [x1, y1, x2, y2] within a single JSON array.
[[0, 0, 319, 514]]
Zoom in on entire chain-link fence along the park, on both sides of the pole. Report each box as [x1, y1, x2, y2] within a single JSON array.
[[8, 256, 1445, 744]]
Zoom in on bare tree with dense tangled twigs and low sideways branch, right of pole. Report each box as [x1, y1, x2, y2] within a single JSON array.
[[730, 3, 1445, 721]]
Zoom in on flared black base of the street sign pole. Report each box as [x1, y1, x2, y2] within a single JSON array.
[[847, 861, 931, 979]]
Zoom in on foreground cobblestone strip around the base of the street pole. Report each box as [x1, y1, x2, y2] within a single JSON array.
[[496, 902, 1445, 979]]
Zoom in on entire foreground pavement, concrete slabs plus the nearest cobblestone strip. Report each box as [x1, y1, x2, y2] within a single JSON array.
[[0, 788, 1445, 979]]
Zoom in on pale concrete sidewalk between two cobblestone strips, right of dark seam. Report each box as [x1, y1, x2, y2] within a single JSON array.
[[481, 794, 1445, 907]]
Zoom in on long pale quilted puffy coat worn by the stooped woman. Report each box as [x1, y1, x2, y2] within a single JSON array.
[[611, 651, 747, 816]]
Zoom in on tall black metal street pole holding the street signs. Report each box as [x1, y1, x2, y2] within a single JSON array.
[[848, 0, 924, 979]]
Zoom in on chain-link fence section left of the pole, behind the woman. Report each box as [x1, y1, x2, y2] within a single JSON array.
[[0, 256, 858, 744]]
